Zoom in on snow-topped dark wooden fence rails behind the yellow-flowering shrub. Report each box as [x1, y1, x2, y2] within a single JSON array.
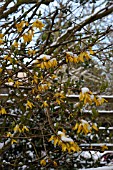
[[0, 91, 113, 150]]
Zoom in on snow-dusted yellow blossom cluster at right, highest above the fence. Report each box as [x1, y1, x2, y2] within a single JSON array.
[[66, 51, 91, 63]]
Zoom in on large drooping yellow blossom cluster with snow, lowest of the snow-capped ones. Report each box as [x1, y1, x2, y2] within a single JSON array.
[[49, 131, 81, 153]]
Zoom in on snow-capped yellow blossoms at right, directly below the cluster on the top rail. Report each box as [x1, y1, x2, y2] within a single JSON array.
[[73, 119, 98, 135]]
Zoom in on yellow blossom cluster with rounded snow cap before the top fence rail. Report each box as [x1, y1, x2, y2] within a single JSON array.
[[79, 87, 107, 106]]
